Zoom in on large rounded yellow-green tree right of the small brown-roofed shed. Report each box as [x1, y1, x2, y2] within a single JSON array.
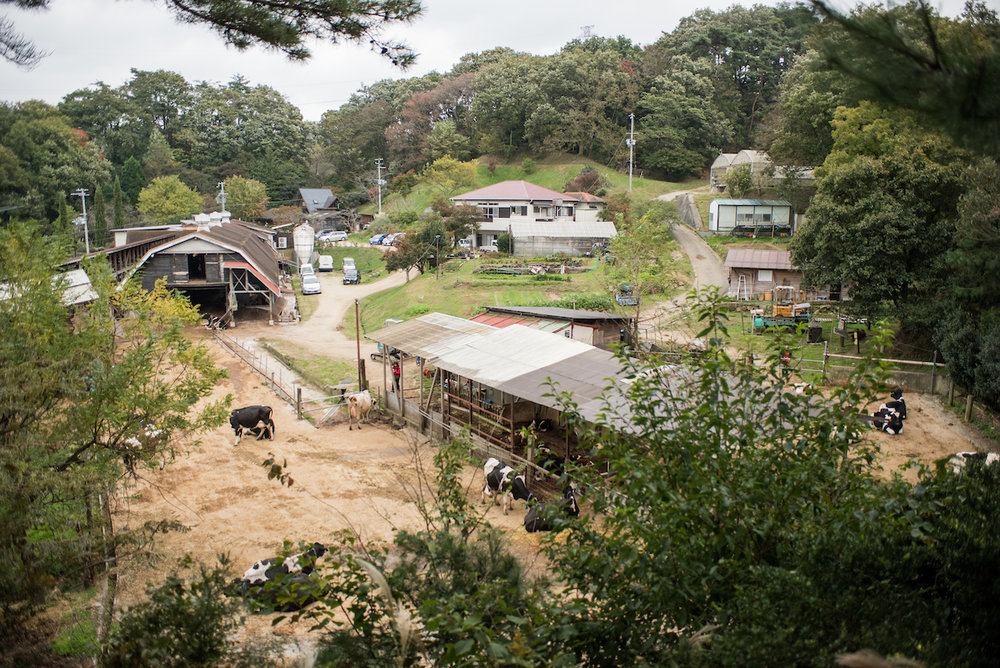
[[791, 103, 967, 320]]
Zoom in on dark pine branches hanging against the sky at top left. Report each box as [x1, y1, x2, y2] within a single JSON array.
[[0, 0, 421, 67]]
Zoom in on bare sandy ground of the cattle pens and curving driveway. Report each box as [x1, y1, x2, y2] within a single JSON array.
[[109, 247, 995, 652]]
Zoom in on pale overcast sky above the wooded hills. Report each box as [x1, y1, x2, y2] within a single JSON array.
[[0, 0, 972, 121]]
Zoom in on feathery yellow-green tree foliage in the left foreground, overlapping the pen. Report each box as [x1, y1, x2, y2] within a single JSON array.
[[0, 225, 224, 638]]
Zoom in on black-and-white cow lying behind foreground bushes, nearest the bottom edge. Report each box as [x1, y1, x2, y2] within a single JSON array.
[[239, 543, 326, 612]]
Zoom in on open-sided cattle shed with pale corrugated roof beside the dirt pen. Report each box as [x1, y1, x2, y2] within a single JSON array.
[[367, 313, 622, 460]]
